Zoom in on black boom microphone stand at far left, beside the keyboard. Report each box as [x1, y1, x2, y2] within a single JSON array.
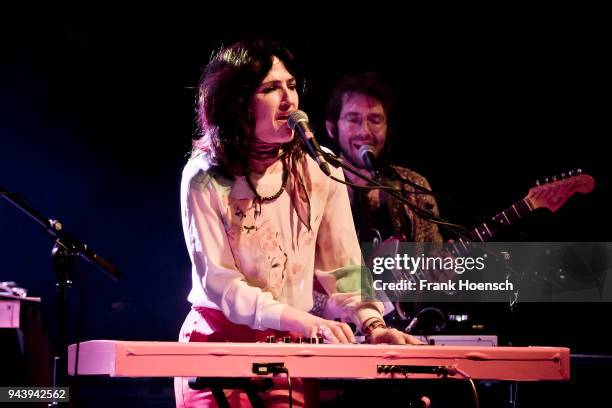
[[0, 185, 122, 406]]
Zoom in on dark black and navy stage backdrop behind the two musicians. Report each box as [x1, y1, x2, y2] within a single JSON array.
[[0, 10, 610, 404]]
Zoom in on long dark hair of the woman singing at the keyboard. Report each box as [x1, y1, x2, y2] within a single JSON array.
[[194, 39, 304, 174]]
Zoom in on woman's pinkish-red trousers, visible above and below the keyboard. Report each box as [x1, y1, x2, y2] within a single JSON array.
[[174, 307, 318, 408]]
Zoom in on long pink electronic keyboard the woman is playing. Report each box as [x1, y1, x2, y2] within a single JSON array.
[[68, 340, 570, 381]]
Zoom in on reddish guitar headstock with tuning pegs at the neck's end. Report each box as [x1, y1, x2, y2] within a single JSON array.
[[526, 170, 595, 212]]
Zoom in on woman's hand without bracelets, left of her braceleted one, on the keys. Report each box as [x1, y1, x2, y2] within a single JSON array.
[[281, 306, 356, 343]]
